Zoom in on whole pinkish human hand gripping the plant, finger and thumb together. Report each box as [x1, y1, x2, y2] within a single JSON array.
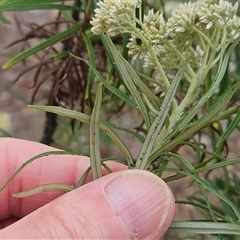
[[0, 138, 175, 239]]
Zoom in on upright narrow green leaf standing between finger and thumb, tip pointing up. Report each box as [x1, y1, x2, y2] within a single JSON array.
[[90, 83, 102, 180]]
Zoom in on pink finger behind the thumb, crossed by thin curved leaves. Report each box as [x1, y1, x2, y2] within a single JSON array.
[[0, 138, 126, 220]]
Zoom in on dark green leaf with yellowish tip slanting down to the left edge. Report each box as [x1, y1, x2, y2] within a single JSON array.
[[3, 24, 83, 69]]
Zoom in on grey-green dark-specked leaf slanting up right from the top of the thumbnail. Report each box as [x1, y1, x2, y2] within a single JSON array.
[[136, 62, 187, 169]]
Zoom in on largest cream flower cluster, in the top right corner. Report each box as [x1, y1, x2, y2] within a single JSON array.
[[145, 0, 240, 69]]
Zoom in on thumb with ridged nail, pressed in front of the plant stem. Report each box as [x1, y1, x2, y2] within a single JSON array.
[[0, 170, 175, 239]]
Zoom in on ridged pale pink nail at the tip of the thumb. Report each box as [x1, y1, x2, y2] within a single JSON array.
[[105, 170, 175, 239]]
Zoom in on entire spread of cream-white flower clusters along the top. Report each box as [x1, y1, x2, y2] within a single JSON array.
[[91, 0, 240, 73]]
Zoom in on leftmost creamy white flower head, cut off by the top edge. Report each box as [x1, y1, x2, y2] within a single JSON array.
[[90, 0, 141, 36]]
